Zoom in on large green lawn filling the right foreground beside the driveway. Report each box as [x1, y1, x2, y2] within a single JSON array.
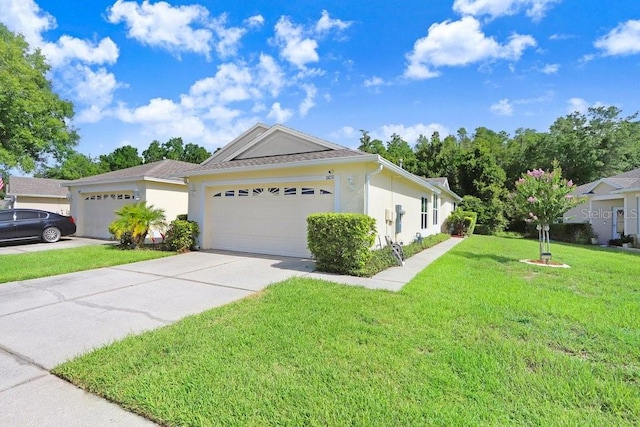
[[54, 236, 640, 426]]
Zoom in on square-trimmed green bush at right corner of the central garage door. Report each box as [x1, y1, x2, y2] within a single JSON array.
[[307, 213, 376, 276]]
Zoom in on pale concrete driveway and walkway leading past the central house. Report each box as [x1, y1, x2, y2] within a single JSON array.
[[0, 238, 462, 426]]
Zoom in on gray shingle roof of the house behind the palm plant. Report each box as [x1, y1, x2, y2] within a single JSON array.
[[69, 160, 199, 185]]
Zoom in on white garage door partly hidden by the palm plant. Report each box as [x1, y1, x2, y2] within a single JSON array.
[[76, 193, 135, 239]]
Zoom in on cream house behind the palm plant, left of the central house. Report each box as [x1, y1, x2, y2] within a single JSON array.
[[65, 160, 198, 239]]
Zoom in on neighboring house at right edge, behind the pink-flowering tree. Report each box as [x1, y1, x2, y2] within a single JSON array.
[[565, 168, 640, 244]]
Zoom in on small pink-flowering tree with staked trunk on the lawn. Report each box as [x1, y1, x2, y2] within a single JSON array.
[[512, 161, 584, 261]]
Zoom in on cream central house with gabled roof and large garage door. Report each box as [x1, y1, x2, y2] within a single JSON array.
[[184, 124, 461, 256]]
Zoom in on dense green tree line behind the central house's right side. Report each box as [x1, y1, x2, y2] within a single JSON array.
[[359, 106, 640, 232]]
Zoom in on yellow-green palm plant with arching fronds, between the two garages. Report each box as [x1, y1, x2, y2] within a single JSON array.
[[109, 201, 166, 248]]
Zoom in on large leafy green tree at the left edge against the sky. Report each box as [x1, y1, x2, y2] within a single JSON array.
[[0, 24, 78, 172]]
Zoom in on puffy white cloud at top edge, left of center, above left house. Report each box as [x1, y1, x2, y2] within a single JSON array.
[[107, 0, 213, 57]]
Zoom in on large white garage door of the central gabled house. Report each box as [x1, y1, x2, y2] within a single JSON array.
[[208, 183, 334, 257]]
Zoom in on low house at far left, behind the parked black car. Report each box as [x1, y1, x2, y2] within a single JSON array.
[[5, 176, 69, 215]]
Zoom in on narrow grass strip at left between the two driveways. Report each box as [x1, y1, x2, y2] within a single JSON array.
[[0, 245, 175, 283]]
